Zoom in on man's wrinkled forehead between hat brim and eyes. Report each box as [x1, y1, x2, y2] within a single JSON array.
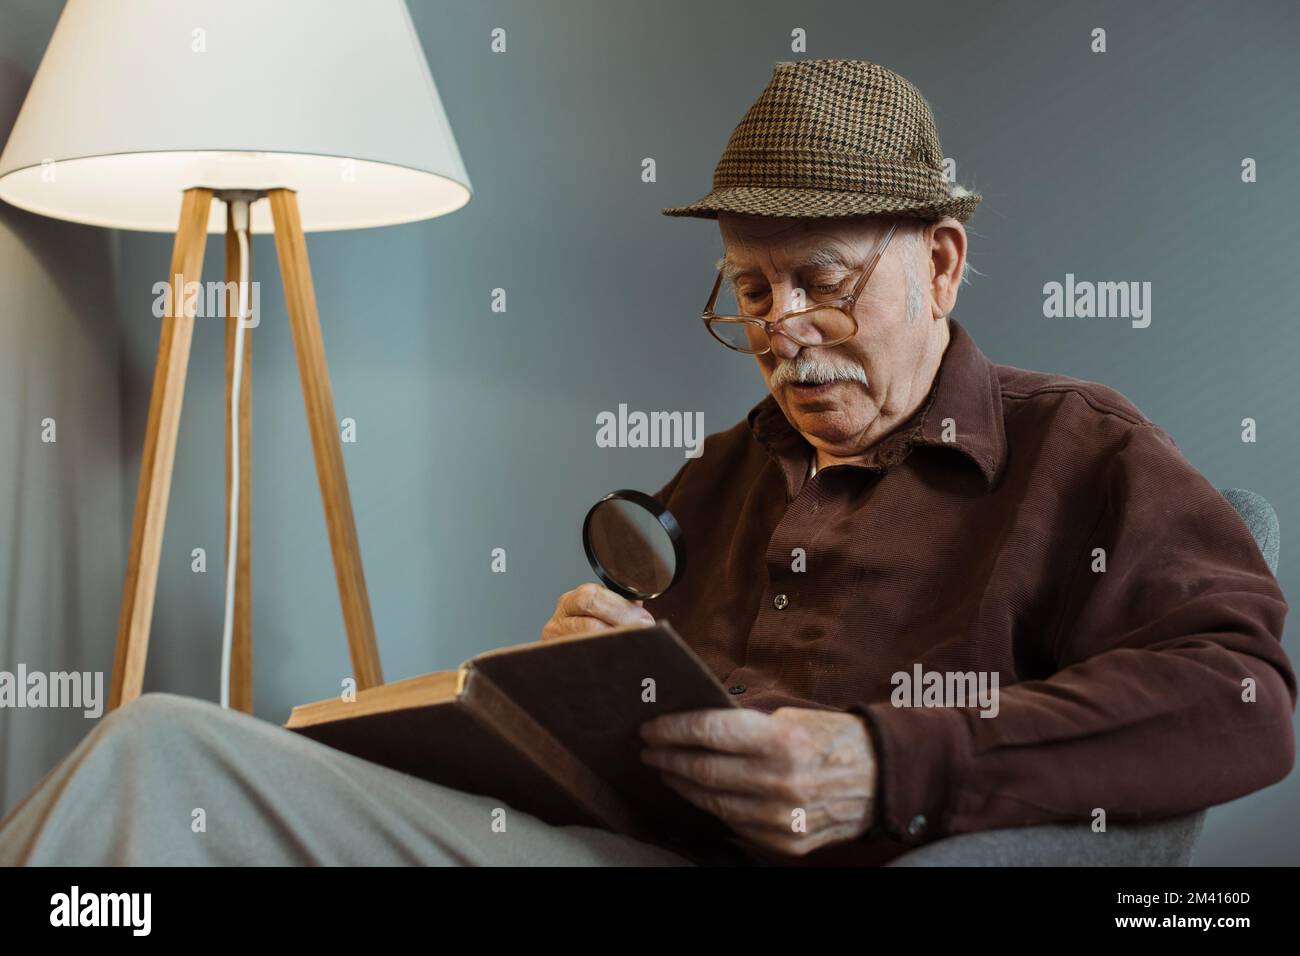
[[718, 213, 889, 278]]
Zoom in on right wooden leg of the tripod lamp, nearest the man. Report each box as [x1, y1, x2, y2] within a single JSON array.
[[268, 189, 384, 689]]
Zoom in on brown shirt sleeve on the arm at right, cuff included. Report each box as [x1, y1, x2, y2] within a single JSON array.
[[849, 424, 1296, 844]]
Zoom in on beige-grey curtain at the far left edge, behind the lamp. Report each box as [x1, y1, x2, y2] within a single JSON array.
[[0, 0, 126, 812]]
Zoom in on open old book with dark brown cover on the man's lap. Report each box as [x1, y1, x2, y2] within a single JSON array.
[[285, 620, 738, 845]]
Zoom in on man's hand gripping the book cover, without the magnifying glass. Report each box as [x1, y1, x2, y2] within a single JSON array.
[[641, 708, 876, 856]]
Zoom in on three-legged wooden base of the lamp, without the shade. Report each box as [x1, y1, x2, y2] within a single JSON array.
[[108, 189, 384, 713]]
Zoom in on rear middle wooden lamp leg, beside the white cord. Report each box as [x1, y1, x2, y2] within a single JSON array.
[[225, 203, 252, 714]]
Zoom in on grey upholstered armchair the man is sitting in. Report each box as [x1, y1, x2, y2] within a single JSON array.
[[889, 488, 1282, 866]]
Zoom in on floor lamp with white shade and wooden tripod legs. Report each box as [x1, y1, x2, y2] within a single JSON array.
[[0, 0, 471, 713]]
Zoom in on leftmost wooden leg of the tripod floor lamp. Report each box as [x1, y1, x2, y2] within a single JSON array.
[[108, 189, 212, 710]]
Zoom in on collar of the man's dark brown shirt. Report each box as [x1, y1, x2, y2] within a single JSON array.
[[746, 319, 1006, 498]]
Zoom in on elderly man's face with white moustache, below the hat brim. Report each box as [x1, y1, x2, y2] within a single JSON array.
[[719, 213, 965, 458]]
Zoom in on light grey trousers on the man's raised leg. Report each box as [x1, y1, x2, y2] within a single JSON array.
[[0, 693, 692, 866]]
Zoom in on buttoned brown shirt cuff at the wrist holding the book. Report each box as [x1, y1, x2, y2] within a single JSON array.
[[848, 701, 971, 845]]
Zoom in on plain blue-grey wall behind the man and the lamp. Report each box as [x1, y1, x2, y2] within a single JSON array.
[[0, 0, 1300, 864]]
